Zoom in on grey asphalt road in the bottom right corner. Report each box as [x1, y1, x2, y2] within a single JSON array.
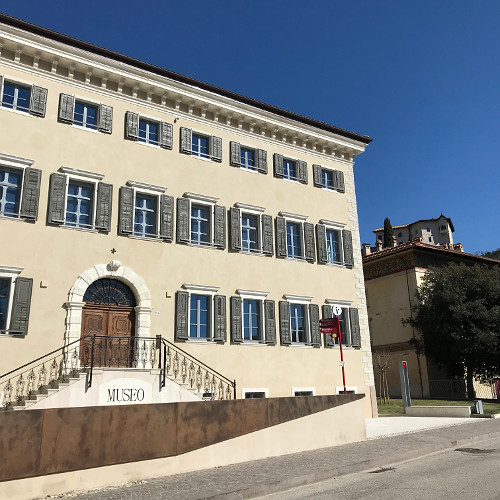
[[259, 438, 500, 500]]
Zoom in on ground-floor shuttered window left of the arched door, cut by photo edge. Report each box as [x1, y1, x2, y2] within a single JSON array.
[[0, 266, 33, 335]]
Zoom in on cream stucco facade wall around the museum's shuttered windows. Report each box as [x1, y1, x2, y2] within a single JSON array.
[[0, 28, 373, 416]]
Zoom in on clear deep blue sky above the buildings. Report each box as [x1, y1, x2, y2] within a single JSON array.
[[1, 0, 500, 253]]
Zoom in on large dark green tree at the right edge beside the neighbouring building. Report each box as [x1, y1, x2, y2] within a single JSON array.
[[407, 263, 500, 398]]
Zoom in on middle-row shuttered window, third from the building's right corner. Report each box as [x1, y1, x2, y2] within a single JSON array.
[[230, 203, 273, 255]]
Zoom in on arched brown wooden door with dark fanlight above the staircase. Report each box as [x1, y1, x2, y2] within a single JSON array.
[[80, 278, 135, 367]]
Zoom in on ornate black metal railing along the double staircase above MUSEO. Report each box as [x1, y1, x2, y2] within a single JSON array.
[[0, 335, 236, 408]]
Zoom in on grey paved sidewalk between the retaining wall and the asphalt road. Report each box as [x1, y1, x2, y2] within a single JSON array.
[[52, 417, 500, 500]]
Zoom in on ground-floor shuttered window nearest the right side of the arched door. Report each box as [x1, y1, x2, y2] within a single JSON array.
[[175, 283, 226, 342]]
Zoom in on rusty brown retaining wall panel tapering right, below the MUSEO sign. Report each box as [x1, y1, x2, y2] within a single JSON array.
[[0, 394, 364, 481]]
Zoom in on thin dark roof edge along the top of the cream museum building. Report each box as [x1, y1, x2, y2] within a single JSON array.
[[0, 13, 373, 144]]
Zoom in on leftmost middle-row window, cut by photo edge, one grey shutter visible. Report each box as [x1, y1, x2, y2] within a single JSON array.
[[0, 153, 42, 220]]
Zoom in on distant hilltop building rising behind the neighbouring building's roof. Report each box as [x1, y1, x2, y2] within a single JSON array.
[[362, 214, 464, 256]]
